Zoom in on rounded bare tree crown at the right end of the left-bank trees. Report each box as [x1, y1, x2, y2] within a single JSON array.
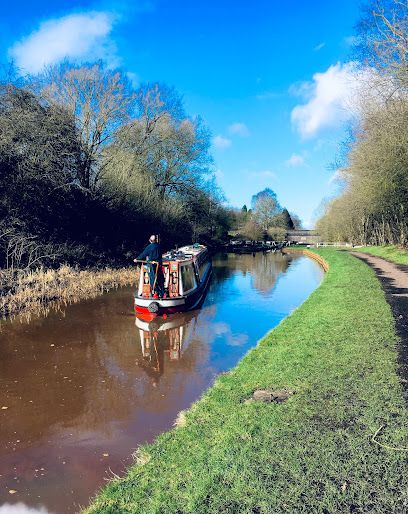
[[100, 84, 211, 200]]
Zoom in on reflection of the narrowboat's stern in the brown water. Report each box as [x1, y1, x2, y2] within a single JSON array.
[[136, 311, 199, 386]]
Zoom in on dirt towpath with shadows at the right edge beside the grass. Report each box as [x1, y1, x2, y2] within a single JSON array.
[[351, 252, 408, 382]]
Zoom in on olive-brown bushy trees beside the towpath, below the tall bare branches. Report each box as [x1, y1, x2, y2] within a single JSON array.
[[318, 97, 408, 245]]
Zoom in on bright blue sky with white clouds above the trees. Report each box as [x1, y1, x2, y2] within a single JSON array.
[[0, 0, 359, 226]]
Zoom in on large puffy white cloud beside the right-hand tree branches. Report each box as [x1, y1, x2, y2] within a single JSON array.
[[291, 62, 368, 138]]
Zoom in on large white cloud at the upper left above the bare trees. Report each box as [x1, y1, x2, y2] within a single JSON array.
[[9, 11, 118, 73]]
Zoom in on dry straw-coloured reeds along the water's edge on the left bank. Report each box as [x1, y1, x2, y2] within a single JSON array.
[[0, 266, 136, 318]]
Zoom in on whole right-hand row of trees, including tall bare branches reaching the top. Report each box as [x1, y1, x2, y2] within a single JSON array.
[[317, 0, 408, 246]]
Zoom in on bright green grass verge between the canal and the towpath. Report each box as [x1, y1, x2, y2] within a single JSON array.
[[85, 249, 408, 514]]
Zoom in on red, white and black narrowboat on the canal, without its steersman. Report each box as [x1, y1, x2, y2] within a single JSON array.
[[135, 244, 212, 319]]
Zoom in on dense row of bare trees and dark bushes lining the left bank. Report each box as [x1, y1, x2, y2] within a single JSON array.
[[0, 62, 230, 269]]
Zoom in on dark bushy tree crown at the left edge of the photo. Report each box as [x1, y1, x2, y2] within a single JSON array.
[[0, 84, 80, 216]]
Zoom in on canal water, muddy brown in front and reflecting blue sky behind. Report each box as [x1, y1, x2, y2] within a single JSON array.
[[0, 253, 323, 514]]
